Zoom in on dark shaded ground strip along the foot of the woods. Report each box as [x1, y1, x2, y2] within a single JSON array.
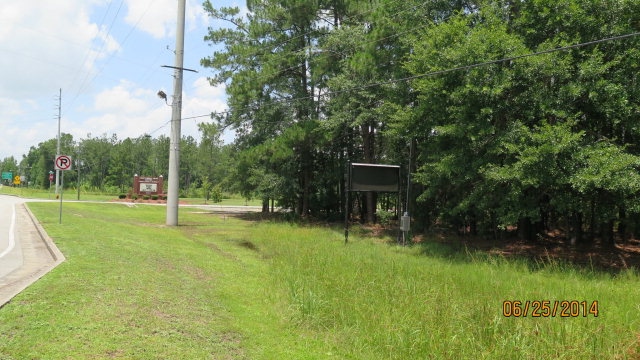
[[191, 212, 640, 274]]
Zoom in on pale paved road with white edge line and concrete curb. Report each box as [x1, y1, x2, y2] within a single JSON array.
[[0, 195, 64, 308]]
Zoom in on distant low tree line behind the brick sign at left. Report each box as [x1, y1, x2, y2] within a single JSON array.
[[0, 123, 232, 197]]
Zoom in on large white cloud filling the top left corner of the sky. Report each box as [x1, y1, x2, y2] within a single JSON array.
[[0, 0, 118, 98]]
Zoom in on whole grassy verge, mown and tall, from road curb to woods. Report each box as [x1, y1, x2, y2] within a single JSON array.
[[0, 203, 640, 360]]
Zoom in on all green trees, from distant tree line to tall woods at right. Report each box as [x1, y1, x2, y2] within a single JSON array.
[[1, 0, 640, 243]]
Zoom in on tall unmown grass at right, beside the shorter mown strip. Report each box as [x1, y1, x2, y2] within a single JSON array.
[[253, 225, 640, 359]]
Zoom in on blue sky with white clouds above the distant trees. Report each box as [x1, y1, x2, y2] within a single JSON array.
[[0, 0, 244, 162]]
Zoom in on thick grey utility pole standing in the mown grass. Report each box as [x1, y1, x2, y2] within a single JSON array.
[[167, 0, 186, 226]]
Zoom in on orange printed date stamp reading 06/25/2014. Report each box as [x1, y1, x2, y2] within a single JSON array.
[[502, 300, 599, 317]]
